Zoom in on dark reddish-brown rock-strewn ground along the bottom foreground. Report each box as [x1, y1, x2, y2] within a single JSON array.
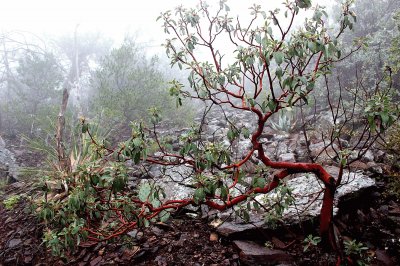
[[0, 178, 400, 266]]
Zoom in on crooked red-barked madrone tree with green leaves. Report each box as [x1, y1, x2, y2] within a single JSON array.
[[38, 0, 396, 254]]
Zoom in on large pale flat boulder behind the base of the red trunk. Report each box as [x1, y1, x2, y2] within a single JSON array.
[[216, 167, 376, 238]]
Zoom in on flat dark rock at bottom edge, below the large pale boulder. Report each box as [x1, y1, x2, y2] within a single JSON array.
[[234, 241, 293, 265]]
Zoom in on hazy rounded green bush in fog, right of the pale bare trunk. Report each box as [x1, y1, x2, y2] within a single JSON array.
[[90, 40, 194, 128]]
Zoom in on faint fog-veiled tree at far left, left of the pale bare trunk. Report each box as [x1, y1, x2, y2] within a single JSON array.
[[4, 50, 63, 135]]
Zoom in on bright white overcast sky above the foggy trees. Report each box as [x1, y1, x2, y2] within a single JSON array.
[[0, 0, 332, 55]]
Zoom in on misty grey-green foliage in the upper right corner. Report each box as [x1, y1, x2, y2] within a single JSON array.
[[338, 0, 400, 87]]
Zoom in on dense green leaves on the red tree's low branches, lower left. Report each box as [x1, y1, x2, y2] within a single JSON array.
[[36, 121, 173, 256]]
